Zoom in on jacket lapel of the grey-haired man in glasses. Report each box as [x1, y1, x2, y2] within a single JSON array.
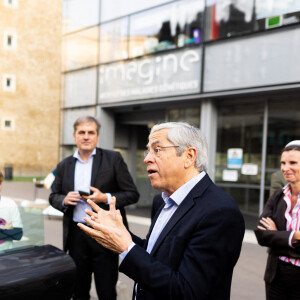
[[147, 175, 211, 255]]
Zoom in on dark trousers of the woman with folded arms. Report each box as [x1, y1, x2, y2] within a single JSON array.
[[266, 260, 300, 300]]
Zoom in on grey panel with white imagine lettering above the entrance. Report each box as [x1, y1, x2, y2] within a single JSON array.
[[99, 48, 201, 103]]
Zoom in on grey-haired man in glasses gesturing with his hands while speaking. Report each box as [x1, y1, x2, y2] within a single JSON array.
[[78, 123, 245, 300]]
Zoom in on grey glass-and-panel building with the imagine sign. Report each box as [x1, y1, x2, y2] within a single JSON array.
[[61, 0, 300, 227]]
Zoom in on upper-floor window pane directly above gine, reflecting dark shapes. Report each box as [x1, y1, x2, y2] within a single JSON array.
[[129, 0, 204, 57]]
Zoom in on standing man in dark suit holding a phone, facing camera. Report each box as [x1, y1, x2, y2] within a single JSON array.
[[49, 116, 139, 300]]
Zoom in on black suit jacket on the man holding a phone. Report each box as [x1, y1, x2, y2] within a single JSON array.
[[49, 148, 139, 251]]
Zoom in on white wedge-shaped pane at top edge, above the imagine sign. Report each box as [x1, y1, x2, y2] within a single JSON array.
[[101, 0, 170, 22]]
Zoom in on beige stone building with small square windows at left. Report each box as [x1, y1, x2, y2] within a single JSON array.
[[0, 0, 62, 178]]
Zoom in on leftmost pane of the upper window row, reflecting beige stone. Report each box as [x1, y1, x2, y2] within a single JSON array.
[[63, 26, 99, 71]]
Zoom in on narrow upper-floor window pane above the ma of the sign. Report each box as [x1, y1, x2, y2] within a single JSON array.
[[100, 18, 128, 63]]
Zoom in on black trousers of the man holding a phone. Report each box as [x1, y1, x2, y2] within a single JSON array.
[[69, 223, 119, 300]]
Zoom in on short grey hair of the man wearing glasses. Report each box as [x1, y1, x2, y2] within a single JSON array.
[[150, 122, 208, 172]]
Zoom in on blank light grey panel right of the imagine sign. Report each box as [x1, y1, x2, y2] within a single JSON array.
[[203, 26, 300, 92]]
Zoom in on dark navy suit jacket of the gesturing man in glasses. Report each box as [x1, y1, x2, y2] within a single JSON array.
[[119, 175, 245, 300]]
